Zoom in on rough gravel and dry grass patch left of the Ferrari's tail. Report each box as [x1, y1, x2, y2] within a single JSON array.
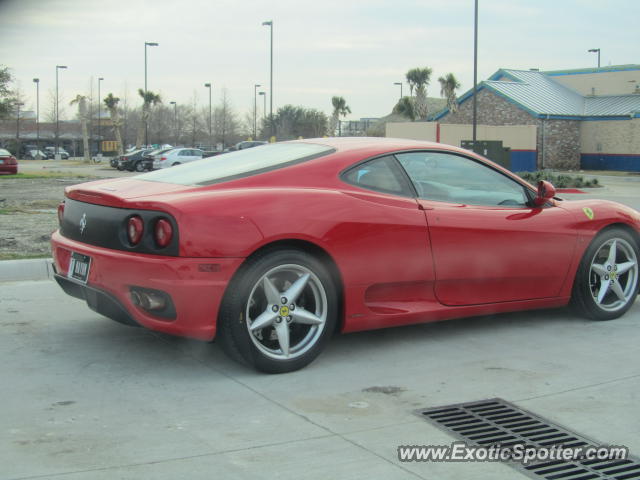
[[0, 177, 96, 260]]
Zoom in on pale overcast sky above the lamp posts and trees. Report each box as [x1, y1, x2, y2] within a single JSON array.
[[0, 0, 640, 120]]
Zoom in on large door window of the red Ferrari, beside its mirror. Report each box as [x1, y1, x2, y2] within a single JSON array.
[[396, 152, 529, 207]]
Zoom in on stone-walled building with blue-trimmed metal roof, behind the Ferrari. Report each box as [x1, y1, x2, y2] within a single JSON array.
[[433, 65, 640, 171]]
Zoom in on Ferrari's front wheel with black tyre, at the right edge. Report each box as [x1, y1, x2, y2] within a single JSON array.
[[572, 228, 640, 320]]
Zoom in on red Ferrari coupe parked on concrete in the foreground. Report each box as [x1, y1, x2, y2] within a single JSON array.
[[52, 138, 640, 372]]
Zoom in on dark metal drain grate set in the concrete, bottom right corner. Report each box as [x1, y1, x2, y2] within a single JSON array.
[[418, 398, 640, 480]]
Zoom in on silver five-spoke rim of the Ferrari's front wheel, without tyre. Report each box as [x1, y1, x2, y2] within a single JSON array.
[[589, 238, 638, 312]]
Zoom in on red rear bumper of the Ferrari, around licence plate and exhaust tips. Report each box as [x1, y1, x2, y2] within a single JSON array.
[[51, 232, 244, 340]]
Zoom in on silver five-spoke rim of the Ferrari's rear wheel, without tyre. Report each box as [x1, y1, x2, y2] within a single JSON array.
[[245, 264, 328, 360]]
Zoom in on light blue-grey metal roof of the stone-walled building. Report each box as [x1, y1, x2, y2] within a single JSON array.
[[482, 69, 640, 117]]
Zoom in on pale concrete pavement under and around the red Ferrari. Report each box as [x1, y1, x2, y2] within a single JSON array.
[[0, 171, 640, 479]]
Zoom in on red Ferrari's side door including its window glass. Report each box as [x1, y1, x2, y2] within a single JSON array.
[[396, 152, 577, 305]]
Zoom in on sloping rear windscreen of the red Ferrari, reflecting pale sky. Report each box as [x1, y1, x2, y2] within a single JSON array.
[[141, 143, 334, 185]]
